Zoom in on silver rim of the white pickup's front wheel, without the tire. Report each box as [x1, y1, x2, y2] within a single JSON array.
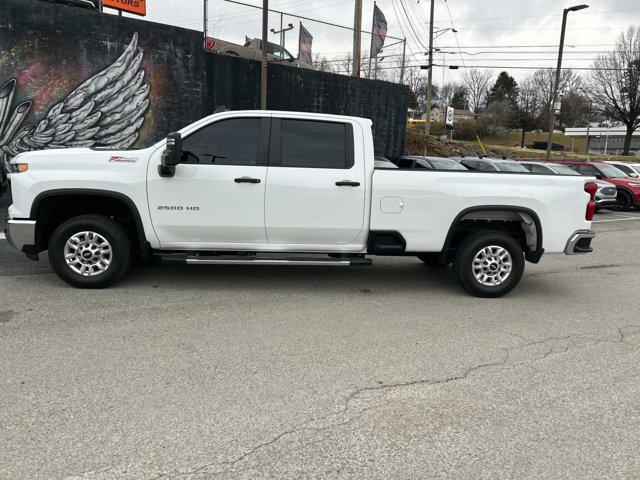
[[64, 232, 113, 277]]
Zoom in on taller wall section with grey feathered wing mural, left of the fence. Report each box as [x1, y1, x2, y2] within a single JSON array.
[[0, 0, 206, 162]]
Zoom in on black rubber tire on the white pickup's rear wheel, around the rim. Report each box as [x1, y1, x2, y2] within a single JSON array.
[[453, 231, 525, 298]]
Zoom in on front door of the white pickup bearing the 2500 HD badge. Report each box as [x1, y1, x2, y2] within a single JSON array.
[[147, 117, 270, 248]]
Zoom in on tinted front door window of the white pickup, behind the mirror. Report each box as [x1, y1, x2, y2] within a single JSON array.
[[182, 118, 261, 165]]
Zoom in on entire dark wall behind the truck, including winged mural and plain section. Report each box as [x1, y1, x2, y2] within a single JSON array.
[[0, 0, 408, 155]]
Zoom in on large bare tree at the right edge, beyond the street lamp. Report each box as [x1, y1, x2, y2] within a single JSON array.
[[589, 26, 640, 155]]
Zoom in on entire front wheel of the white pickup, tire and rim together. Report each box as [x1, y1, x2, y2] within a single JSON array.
[[49, 215, 132, 288]]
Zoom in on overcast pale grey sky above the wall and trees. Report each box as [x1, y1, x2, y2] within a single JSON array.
[[107, 0, 640, 83]]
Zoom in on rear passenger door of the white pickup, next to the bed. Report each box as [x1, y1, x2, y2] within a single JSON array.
[[265, 118, 366, 245]]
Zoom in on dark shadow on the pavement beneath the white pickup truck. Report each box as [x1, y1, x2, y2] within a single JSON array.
[[116, 258, 566, 297]]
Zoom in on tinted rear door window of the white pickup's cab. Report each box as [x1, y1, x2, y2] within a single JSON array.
[[280, 119, 353, 168]]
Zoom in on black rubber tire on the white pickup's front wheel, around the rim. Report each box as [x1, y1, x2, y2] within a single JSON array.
[[49, 215, 133, 288]]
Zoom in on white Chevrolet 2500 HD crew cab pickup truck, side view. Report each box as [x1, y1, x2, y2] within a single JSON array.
[[5, 111, 597, 297]]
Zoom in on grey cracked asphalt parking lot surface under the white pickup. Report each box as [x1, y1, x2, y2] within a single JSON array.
[[0, 196, 640, 479]]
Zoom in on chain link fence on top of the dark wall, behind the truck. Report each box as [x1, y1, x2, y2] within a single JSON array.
[[203, 0, 406, 83]]
